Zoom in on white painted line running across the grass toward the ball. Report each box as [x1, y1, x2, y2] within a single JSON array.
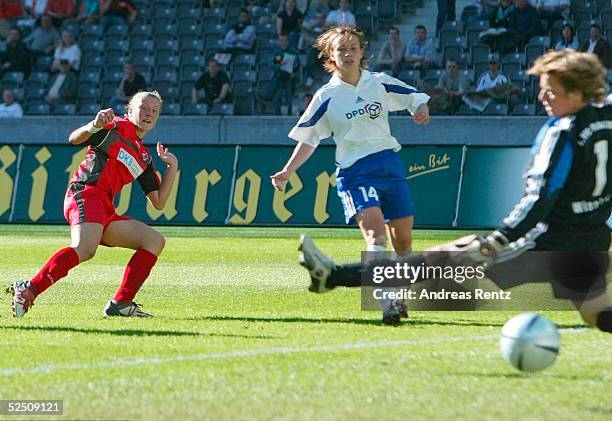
[[0, 328, 589, 376]]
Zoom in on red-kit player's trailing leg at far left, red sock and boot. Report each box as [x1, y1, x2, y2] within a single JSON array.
[[11, 222, 103, 317]]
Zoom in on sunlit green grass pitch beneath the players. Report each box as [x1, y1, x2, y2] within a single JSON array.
[[0, 225, 612, 420]]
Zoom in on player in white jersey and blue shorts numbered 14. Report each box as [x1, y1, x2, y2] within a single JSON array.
[[271, 26, 429, 324]]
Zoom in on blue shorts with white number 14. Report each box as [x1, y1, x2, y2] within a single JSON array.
[[336, 149, 415, 224]]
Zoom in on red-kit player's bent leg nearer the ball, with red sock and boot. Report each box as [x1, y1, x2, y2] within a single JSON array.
[[102, 219, 166, 317]]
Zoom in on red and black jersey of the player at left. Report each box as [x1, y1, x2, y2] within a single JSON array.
[[70, 117, 160, 201]]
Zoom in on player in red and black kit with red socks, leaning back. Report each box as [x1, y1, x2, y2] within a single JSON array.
[[13, 91, 178, 317]]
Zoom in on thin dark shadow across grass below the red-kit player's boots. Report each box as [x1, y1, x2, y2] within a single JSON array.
[[0, 326, 281, 339]]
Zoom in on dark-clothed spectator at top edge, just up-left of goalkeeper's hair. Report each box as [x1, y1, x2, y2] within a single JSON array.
[[497, 0, 542, 54]]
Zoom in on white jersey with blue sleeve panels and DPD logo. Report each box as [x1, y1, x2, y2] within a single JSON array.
[[289, 70, 429, 168]]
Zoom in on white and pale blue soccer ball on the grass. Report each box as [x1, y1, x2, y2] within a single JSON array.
[[499, 313, 561, 371]]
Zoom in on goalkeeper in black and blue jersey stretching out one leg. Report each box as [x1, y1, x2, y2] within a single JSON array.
[[300, 50, 612, 333]]
